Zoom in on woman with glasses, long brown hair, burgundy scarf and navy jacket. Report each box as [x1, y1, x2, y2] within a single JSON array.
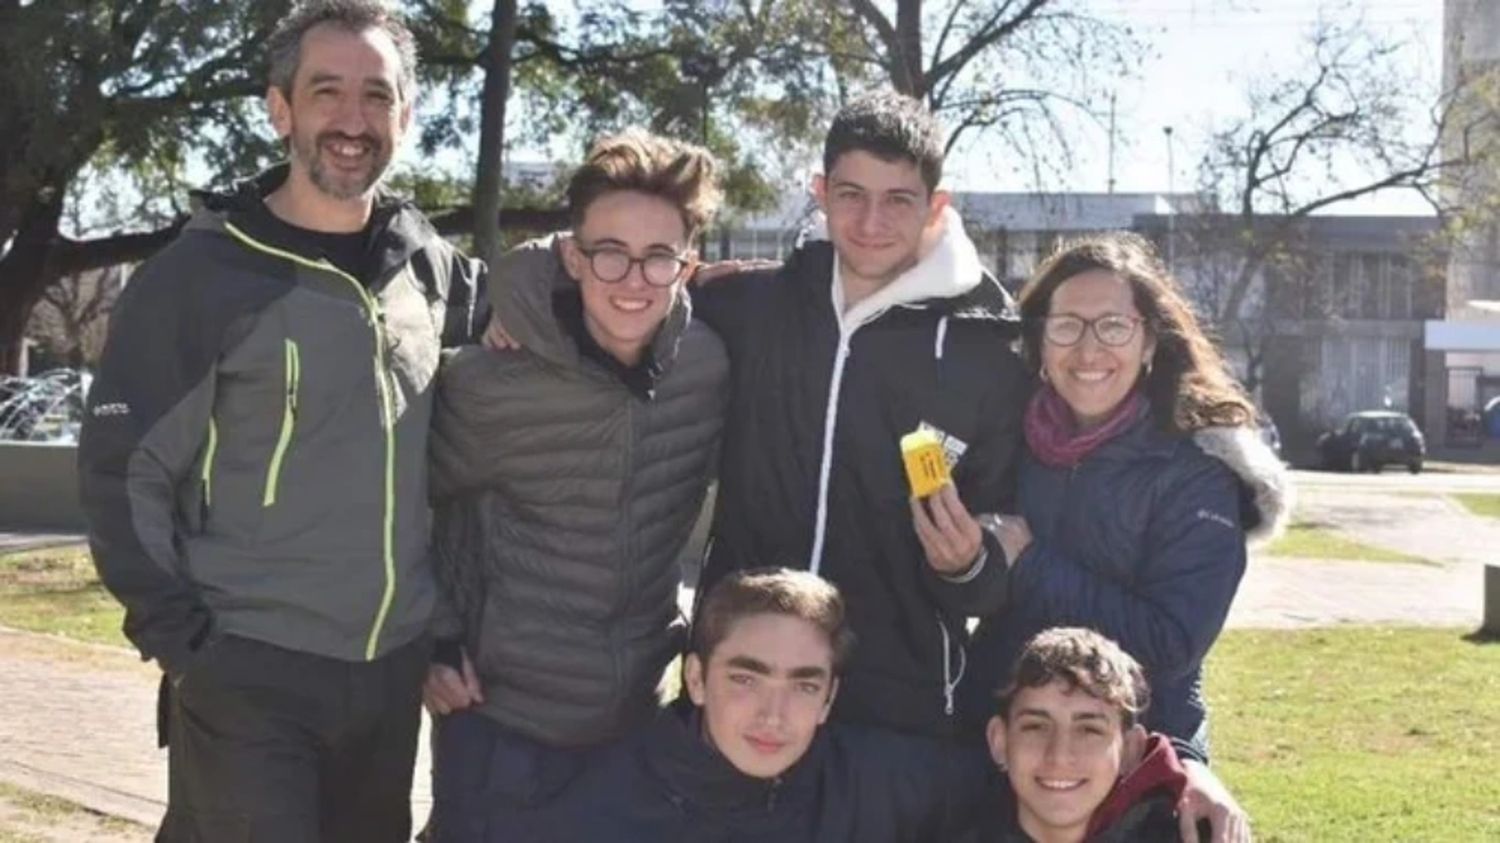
[[966, 234, 1290, 840]]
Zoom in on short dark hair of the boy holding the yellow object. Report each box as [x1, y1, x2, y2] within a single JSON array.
[[824, 92, 944, 192]]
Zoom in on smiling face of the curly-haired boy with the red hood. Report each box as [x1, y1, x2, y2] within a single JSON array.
[[987, 681, 1146, 843]]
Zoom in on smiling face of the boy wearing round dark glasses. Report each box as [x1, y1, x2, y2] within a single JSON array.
[[563, 191, 687, 366]]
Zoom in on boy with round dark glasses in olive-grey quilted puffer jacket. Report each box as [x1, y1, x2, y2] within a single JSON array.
[[426, 131, 729, 842]]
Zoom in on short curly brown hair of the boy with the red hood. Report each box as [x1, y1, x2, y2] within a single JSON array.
[[999, 627, 1151, 729]]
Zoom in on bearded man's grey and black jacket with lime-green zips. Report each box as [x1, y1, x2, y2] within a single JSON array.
[[78, 167, 485, 674]]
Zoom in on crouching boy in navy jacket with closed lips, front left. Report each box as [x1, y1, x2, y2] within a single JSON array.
[[510, 569, 986, 843]]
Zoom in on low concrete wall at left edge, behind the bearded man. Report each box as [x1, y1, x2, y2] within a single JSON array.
[[0, 443, 84, 533]]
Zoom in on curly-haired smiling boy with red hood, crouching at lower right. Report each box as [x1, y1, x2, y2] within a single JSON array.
[[983, 627, 1209, 843]]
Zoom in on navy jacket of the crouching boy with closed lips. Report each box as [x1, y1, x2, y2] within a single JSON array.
[[522, 704, 992, 843]]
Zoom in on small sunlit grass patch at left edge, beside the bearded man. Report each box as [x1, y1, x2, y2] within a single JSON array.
[[0, 545, 128, 647]]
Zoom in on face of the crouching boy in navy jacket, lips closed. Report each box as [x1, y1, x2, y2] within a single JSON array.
[[684, 614, 837, 779]]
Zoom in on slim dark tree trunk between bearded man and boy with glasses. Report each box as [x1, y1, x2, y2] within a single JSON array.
[[474, 0, 516, 266]]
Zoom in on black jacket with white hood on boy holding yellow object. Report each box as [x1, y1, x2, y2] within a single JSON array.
[[693, 209, 1029, 737]]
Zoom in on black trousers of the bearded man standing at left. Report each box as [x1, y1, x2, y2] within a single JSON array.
[[156, 636, 431, 843]]
